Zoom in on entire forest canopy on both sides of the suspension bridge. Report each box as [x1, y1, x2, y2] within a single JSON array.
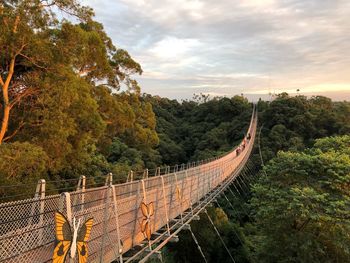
[[0, 0, 350, 262]]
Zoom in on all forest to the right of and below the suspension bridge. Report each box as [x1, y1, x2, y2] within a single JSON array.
[[164, 94, 350, 263]]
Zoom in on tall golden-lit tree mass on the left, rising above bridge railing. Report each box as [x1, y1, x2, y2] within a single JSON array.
[[0, 0, 156, 195]]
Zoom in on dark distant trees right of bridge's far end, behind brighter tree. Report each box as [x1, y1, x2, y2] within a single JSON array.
[[260, 93, 350, 159]]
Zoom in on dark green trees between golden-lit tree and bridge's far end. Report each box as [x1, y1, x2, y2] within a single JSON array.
[[143, 95, 251, 165]]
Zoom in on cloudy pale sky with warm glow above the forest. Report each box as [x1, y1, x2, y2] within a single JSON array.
[[82, 0, 350, 100]]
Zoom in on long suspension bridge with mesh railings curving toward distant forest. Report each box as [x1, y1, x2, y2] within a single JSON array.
[[0, 107, 257, 263]]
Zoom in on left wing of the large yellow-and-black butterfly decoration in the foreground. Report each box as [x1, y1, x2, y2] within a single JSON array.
[[52, 212, 72, 263]]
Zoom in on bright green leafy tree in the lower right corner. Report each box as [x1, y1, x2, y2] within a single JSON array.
[[251, 136, 350, 262]]
